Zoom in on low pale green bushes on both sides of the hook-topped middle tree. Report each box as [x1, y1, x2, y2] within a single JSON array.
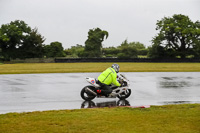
[[64, 40, 149, 58]]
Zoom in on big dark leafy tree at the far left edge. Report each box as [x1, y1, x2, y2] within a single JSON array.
[[0, 20, 45, 60]]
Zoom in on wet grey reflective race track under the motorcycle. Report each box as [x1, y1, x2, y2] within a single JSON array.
[[0, 72, 200, 114]]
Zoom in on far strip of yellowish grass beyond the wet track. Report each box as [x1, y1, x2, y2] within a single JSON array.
[[0, 63, 200, 74]]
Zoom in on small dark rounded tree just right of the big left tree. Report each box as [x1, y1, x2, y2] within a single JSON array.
[[44, 42, 65, 57]]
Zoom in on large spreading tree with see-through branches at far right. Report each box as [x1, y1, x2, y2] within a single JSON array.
[[151, 14, 200, 58]]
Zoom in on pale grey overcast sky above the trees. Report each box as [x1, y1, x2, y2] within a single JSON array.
[[0, 0, 200, 49]]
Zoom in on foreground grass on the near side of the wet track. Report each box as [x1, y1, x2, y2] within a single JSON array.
[[0, 104, 200, 133]]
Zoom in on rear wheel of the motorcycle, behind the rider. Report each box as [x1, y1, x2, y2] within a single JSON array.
[[81, 86, 96, 101]]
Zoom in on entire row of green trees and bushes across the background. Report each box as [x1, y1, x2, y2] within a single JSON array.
[[0, 14, 200, 60]]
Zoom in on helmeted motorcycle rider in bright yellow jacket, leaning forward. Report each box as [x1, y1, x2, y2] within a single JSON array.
[[96, 64, 121, 96]]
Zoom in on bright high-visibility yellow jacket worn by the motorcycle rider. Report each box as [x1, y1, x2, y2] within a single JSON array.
[[98, 67, 121, 86]]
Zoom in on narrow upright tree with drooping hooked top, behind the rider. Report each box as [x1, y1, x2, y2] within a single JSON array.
[[85, 28, 108, 57]]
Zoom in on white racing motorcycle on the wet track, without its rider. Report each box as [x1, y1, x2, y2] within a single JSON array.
[[80, 74, 131, 101]]
